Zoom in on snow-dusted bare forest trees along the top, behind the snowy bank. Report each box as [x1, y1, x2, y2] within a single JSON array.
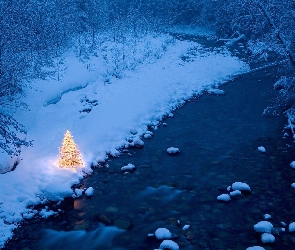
[[0, 0, 295, 154]]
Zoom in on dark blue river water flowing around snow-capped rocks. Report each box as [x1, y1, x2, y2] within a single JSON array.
[[5, 41, 295, 250]]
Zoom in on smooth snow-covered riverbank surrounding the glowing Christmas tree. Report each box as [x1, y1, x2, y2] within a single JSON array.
[[0, 30, 249, 247]]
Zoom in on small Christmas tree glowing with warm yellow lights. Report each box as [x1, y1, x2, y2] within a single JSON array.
[[58, 130, 84, 168]]
